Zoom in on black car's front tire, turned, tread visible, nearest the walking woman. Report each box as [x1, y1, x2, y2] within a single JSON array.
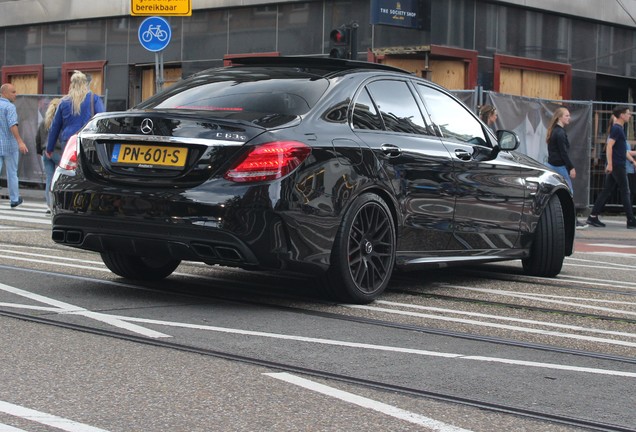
[[522, 196, 565, 277]]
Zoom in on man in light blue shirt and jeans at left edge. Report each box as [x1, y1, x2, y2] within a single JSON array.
[[0, 83, 29, 208]]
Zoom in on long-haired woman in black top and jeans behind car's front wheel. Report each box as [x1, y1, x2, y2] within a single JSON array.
[[546, 107, 587, 229]]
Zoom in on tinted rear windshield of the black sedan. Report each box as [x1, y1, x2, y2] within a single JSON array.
[[137, 69, 329, 118]]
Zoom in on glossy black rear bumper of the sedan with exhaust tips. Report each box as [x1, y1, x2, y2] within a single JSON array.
[[52, 185, 331, 273]]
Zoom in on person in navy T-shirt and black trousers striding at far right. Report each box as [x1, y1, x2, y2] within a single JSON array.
[[587, 106, 636, 229]]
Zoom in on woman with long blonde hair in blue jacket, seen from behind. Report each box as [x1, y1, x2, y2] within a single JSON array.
[[45, 71, 104, 159]]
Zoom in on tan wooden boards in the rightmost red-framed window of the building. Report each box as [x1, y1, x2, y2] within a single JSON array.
[[499, 67, 563, 99]]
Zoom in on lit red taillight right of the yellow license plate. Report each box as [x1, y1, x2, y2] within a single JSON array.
[[224, 141, 311, 182]]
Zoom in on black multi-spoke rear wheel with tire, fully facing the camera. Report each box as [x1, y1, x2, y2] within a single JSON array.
[[323, 193, 396, 304]]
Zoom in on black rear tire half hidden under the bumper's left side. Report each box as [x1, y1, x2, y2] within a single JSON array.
[[101, 252, 181, 281]]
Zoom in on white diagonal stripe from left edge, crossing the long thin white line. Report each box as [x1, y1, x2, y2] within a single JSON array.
[[0, 283, 172, 338]]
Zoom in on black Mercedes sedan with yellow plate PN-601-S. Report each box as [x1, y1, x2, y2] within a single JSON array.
[[52, 57, 575, 303]]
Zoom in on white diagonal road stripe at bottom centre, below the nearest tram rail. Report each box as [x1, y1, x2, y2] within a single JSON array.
[[263, 372, 470, 432]]
